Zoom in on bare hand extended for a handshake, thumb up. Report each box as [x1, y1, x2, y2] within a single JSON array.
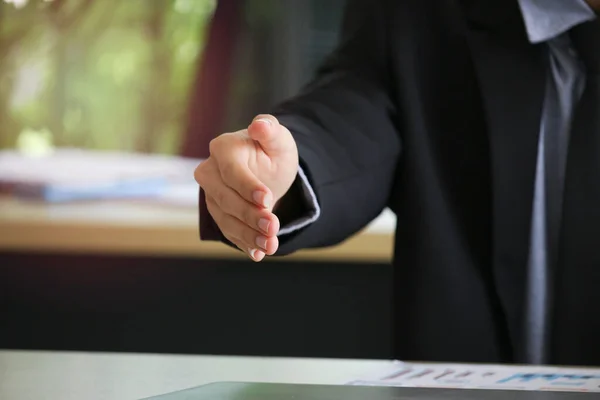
[[194, 115, 298, 261]]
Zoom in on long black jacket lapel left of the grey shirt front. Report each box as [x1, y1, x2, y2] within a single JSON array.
[[465, 0, 546, 361]]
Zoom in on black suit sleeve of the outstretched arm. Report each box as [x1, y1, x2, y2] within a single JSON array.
[[273, 0, 401, 254]]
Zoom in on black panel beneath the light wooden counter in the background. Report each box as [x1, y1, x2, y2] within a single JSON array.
[[0, 253, 391, 358]]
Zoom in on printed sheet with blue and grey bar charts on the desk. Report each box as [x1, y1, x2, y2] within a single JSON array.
[[348, 362, 600, 392]]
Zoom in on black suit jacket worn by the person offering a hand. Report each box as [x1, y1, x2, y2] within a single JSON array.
[[201, 0, 600, 365]]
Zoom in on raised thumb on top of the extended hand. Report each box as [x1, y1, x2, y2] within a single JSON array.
[[248, 114, 295, 156]]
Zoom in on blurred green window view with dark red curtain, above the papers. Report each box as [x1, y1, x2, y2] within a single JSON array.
[[0, 0, 344, 156]]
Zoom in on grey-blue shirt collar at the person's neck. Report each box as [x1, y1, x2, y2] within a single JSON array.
[[516, 0, 596, 43]]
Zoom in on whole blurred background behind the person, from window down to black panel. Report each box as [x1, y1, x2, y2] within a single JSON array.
[[0, 0, 395, 358]]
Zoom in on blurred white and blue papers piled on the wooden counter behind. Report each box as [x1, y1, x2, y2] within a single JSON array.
[[0, 149, 200, 202]]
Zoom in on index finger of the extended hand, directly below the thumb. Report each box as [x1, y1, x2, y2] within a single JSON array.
[[217, 159, 273, 209]]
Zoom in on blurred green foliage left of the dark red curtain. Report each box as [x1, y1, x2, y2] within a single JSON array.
[[0, 0, 216, 153]]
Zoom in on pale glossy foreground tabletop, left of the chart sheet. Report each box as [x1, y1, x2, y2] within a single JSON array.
[[0, 351, 390, 400]]
